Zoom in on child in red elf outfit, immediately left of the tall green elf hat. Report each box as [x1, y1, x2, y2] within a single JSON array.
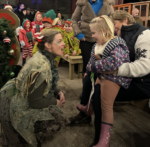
[[32, 11, 43, 33]]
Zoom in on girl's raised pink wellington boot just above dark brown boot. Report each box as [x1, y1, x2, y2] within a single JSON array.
[[77, 101, 93, 116]]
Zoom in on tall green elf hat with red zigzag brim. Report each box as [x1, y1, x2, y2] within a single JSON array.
[[42, 9, 56, 24]]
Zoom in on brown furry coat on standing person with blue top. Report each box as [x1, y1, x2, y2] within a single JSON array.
[[72, 0, 115, 42]]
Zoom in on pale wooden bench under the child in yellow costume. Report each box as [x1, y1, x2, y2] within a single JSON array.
[[62, 56, 83, 80]]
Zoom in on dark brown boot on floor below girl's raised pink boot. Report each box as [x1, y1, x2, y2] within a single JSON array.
[[68, 112, 92, 124]]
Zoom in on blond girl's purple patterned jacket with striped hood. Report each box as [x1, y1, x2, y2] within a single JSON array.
[[87, 37, 132, 89]]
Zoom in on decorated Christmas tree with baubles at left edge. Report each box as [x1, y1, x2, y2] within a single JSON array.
[[0, 18, 15, 88]]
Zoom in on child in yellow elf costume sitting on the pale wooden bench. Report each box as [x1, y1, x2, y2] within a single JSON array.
[[63, 19, 81, 58]]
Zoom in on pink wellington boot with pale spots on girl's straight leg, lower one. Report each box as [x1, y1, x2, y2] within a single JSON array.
[[93, 122, 112, 147]]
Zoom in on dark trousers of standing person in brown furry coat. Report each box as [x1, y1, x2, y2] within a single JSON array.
[[80, 41, 94, 73]]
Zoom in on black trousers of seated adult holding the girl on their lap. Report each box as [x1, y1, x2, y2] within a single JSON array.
[[81, 75, 149, 144]]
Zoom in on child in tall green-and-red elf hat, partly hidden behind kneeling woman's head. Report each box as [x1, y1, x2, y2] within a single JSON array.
[[32, 9, 56, 55]]
